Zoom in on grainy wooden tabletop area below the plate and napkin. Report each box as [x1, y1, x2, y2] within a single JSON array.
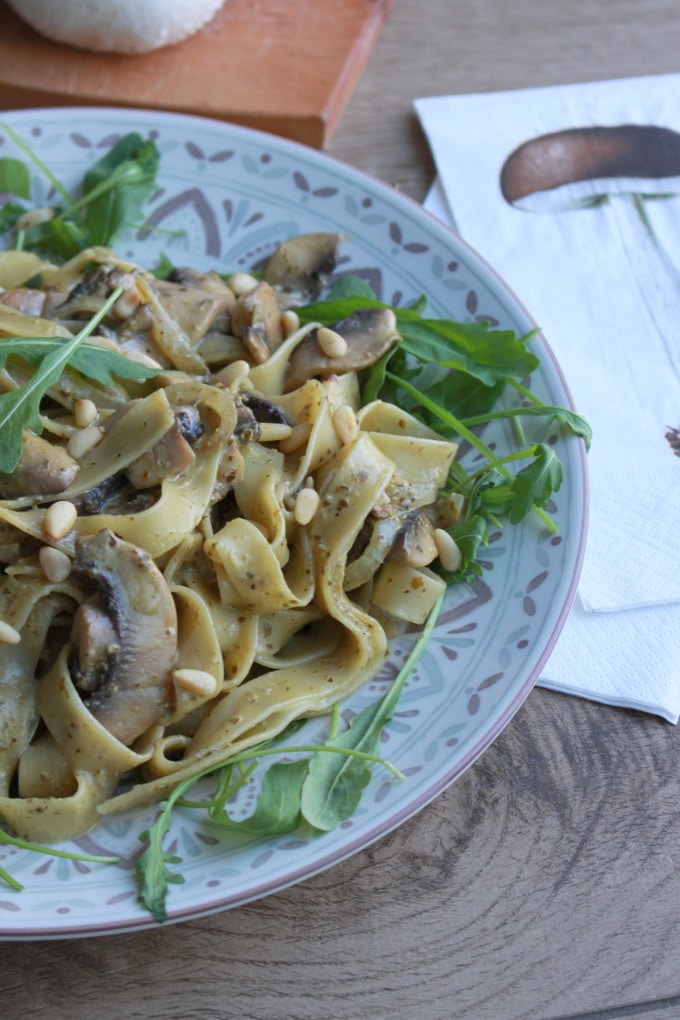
[[3, 691, 680, 1020]]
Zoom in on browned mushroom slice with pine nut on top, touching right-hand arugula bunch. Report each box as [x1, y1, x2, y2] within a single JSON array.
[[284, 308, 400, 393]]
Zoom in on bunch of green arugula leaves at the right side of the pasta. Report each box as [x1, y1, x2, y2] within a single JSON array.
[[297, 274, 590, 583]]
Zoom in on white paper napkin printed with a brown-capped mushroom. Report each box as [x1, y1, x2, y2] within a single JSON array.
[[416, 75, 680, 722]]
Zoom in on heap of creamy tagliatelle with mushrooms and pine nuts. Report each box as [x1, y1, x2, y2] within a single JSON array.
[[0, 240, 456, 842]]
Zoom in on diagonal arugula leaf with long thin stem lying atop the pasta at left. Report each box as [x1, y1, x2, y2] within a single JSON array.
[[0, 288, 122, 473]]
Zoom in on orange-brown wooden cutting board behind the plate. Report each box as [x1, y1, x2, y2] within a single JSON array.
[[0, 0, 395, 148]]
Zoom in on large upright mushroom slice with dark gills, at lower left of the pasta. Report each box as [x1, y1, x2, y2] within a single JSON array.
[[71, 530, 177, 745]]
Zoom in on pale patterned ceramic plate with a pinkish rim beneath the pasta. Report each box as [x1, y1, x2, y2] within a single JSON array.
[[0, 109, 586, 938]]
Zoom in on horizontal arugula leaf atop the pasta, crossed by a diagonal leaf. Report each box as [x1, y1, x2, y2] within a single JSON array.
[[0, 337, 160, 386]]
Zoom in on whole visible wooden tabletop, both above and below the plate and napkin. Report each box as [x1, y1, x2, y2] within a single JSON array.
[[1, 0, 680, 1020]]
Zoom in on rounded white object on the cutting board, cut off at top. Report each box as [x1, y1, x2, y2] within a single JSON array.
[[8, 0, 224, 53]]
